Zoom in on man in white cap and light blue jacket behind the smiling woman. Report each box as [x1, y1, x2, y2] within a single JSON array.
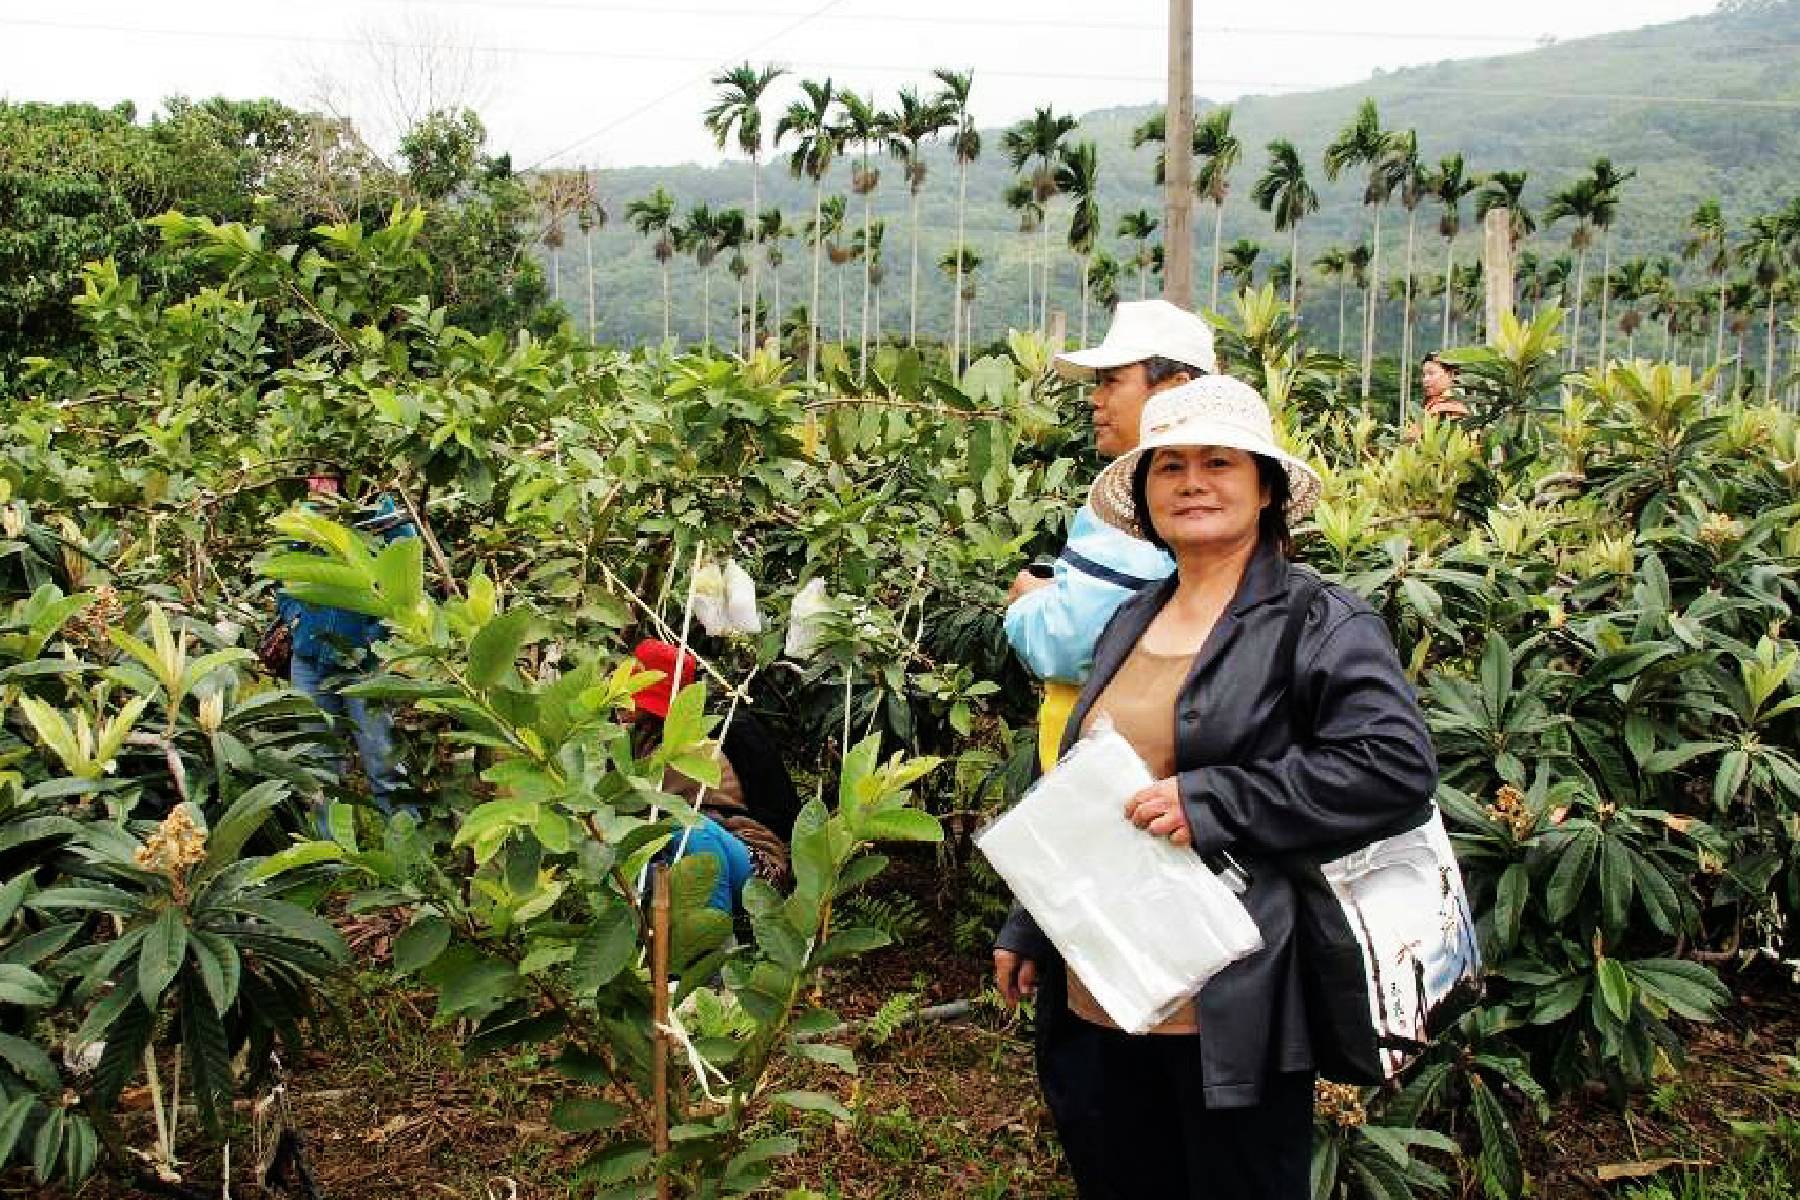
[[1006, 300, 1217, 770]]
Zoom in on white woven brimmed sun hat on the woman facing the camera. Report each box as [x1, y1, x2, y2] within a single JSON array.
[[1087, 374, 1323, 538]]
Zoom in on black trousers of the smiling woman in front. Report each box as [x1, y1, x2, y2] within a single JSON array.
[[1040, 1015, 1312, 1200]]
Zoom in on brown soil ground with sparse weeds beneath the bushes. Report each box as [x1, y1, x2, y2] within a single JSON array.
[[24, 849, 1800, 1200]]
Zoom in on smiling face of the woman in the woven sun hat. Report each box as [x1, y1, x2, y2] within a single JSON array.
[[1145, 446, 1269, 554]]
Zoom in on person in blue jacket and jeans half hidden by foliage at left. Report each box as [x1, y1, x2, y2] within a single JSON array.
[[275, 471, 418, 813]]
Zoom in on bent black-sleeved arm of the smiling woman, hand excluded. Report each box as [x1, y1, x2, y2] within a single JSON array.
[[1177, 610, 1438, 855]]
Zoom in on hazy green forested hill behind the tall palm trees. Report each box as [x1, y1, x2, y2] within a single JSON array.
[[576, 0, 1800, 340]]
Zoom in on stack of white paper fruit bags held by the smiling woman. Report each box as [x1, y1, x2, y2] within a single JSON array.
[[976, 729, 1262, 1033]]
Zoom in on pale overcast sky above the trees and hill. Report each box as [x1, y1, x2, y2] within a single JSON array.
[[0, 0, 1715, 167]]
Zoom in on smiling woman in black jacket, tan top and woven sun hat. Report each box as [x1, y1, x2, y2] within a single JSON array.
[[994, 376, 1436, 1200]]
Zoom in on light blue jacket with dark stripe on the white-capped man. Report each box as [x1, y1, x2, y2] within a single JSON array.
[[1006, 504, 1175, 684]]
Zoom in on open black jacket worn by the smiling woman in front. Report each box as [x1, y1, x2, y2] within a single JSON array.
[[997, 543, 1438, 1108]]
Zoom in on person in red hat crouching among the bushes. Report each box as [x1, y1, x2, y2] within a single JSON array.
[[632, 639, 799, 912]]
